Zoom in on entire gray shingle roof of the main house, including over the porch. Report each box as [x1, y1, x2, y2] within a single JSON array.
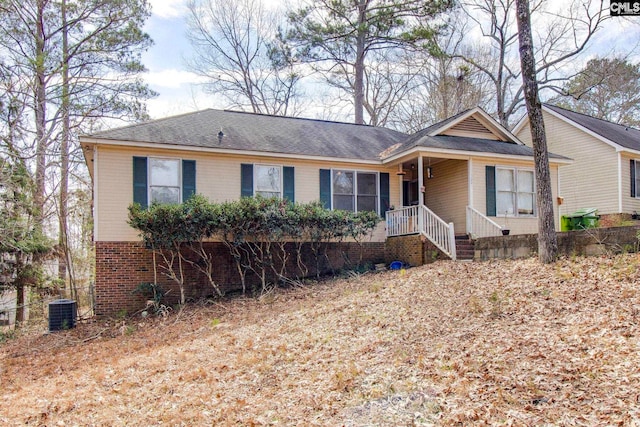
[[89, 109, 562, 161]]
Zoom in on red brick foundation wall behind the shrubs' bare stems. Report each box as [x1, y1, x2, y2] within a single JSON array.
[[95, 242, 385, 316]]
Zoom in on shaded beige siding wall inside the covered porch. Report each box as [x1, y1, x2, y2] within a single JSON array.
[[424, 160, 469, 234]]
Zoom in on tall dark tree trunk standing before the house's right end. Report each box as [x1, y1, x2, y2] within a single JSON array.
[[516, 0, 558, 264]]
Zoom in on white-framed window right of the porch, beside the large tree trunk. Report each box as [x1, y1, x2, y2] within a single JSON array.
[[496, 167, 535, 216]]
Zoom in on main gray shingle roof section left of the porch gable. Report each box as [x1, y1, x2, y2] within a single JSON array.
[[91, 109, 407, 160]]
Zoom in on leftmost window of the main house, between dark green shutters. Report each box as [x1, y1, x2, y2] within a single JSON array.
[[149, 158, 182, 203]]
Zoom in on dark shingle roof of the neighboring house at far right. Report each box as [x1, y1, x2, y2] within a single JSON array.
[[544, 104, 640, 151]]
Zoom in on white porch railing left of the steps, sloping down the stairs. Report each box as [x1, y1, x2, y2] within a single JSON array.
[[386, 206, 456, 260]]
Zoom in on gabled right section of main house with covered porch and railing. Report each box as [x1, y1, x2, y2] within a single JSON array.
[[376, 108, 570, 260]]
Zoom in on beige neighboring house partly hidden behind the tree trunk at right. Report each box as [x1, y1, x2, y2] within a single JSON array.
[[513, 104, 640, 221]]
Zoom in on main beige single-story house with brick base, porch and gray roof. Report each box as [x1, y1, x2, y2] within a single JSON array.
[[80, 108, 570, 312]]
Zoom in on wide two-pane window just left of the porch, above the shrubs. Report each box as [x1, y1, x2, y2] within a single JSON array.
[[331, 170, 378, 212]]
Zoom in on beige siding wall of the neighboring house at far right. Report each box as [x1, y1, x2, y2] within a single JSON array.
[[516, 111, 620, 215]]
